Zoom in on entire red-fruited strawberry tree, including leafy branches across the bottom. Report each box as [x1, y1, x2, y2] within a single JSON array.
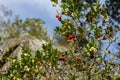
[[0, 0, 120, 80]]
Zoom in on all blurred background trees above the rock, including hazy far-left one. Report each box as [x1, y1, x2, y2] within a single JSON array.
[[0, 5, 48, 42]]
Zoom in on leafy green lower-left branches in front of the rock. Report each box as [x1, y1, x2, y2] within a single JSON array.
[[0, 43, 76, 80]]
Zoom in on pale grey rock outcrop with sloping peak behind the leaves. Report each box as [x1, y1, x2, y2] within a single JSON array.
[[0, 33, 67, 74]]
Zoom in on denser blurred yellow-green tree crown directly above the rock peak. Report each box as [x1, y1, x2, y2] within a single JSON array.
[[4, 18, 48, 40]]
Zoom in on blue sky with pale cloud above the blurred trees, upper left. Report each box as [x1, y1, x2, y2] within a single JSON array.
[[0, 0, 60, 35]]
